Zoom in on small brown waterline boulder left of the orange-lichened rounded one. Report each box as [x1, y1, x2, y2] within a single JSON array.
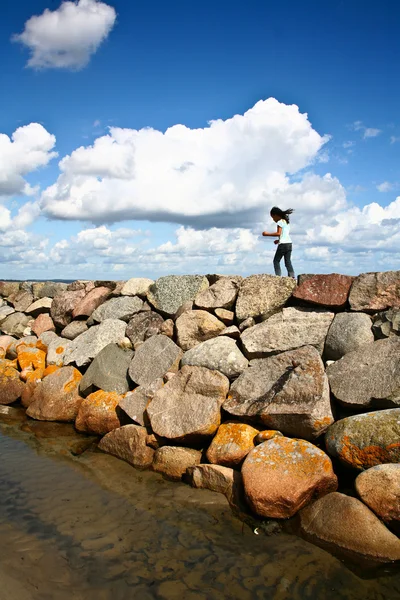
[[153, 446, 201, 481]]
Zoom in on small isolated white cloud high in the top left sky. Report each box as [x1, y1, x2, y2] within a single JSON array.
[[13, 0, 117, 69]]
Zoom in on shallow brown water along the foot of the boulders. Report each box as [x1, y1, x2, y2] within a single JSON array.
[[0, 411, 400, 600]]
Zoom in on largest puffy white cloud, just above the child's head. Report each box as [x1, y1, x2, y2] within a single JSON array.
[[42, 98, 338, 228]]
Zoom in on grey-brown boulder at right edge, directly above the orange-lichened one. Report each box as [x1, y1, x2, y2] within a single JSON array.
[[327, 337, 400, 408]]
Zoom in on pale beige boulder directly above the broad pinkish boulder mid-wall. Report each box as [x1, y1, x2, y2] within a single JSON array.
[[182, 336, 248, 377]]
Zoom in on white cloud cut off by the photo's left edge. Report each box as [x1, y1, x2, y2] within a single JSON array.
[[0, 123, 57, 197]]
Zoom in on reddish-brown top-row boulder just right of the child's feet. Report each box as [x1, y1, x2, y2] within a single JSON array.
[[293, 273, 354, 309]]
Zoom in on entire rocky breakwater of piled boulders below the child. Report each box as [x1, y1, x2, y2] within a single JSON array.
[[0, 271, 400, 563]]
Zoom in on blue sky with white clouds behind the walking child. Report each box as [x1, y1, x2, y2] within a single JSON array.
[[0, 0, 400, 279]]
